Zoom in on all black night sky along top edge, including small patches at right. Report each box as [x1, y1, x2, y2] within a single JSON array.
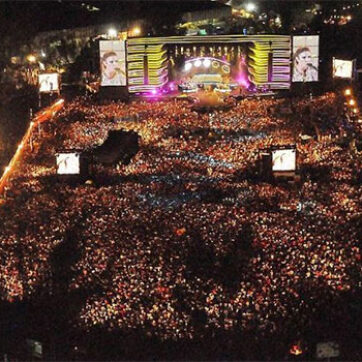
[[0, 0, 355, 40]]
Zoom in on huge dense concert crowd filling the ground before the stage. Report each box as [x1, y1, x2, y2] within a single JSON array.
[[0, 90, 362, 359]]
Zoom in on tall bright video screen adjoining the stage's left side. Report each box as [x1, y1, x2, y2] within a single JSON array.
[[99, 40, 127, 86]]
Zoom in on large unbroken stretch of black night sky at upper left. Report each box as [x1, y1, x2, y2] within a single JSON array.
[[0, 0, 222, 31]]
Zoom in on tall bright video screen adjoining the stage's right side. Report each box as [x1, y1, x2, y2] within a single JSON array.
[[292, 35, 319, 82]]
